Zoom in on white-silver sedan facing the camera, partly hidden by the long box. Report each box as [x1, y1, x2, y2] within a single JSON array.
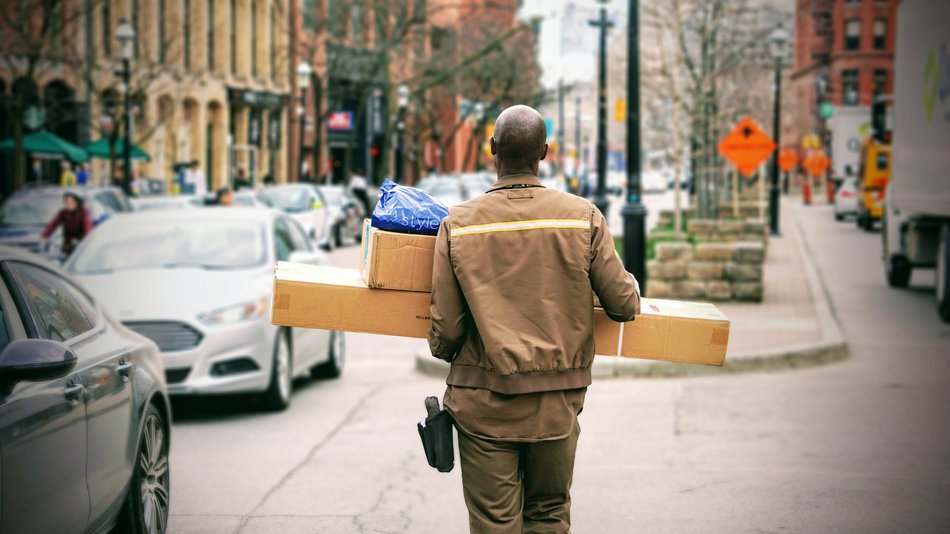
[[66, 207, 344, 410]]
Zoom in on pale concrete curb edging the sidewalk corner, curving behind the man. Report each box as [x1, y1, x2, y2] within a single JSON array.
[[415, 202, 849, 378]]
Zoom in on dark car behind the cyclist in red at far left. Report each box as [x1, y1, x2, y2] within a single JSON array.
[[0, 187, 132, 259]]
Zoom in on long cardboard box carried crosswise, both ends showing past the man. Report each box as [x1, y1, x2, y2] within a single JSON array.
[[271, 262, 729, 365]]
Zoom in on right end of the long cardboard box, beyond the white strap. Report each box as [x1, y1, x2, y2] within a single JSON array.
[[620, 299, 729, 365]]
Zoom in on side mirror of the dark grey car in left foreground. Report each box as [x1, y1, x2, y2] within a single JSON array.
[[0, 339, 76, 385]]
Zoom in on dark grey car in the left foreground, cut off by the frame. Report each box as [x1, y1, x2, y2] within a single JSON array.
[[0, 246, 171, 533]]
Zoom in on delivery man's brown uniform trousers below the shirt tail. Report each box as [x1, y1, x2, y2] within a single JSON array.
[[458, 421, 580, 534]]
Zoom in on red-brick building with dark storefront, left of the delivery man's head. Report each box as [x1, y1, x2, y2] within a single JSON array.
[[291, 0, 539, 183]]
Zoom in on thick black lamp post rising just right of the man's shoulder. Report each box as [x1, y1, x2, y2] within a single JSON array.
[[620, 0, 652, 294]]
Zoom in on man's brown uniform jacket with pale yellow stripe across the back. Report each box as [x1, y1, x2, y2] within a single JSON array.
[[429, 175, 640, 395]]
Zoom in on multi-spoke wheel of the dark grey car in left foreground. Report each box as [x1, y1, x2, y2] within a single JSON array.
[[115, 404, 171, 534]]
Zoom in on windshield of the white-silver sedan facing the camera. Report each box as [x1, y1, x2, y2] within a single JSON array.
[[71, 219, 267, 274]]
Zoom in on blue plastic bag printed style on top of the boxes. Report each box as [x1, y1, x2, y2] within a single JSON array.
[[372, 178, 449, 235]]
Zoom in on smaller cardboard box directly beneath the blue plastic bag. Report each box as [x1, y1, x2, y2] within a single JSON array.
[[360, 219, 435, 293]]
